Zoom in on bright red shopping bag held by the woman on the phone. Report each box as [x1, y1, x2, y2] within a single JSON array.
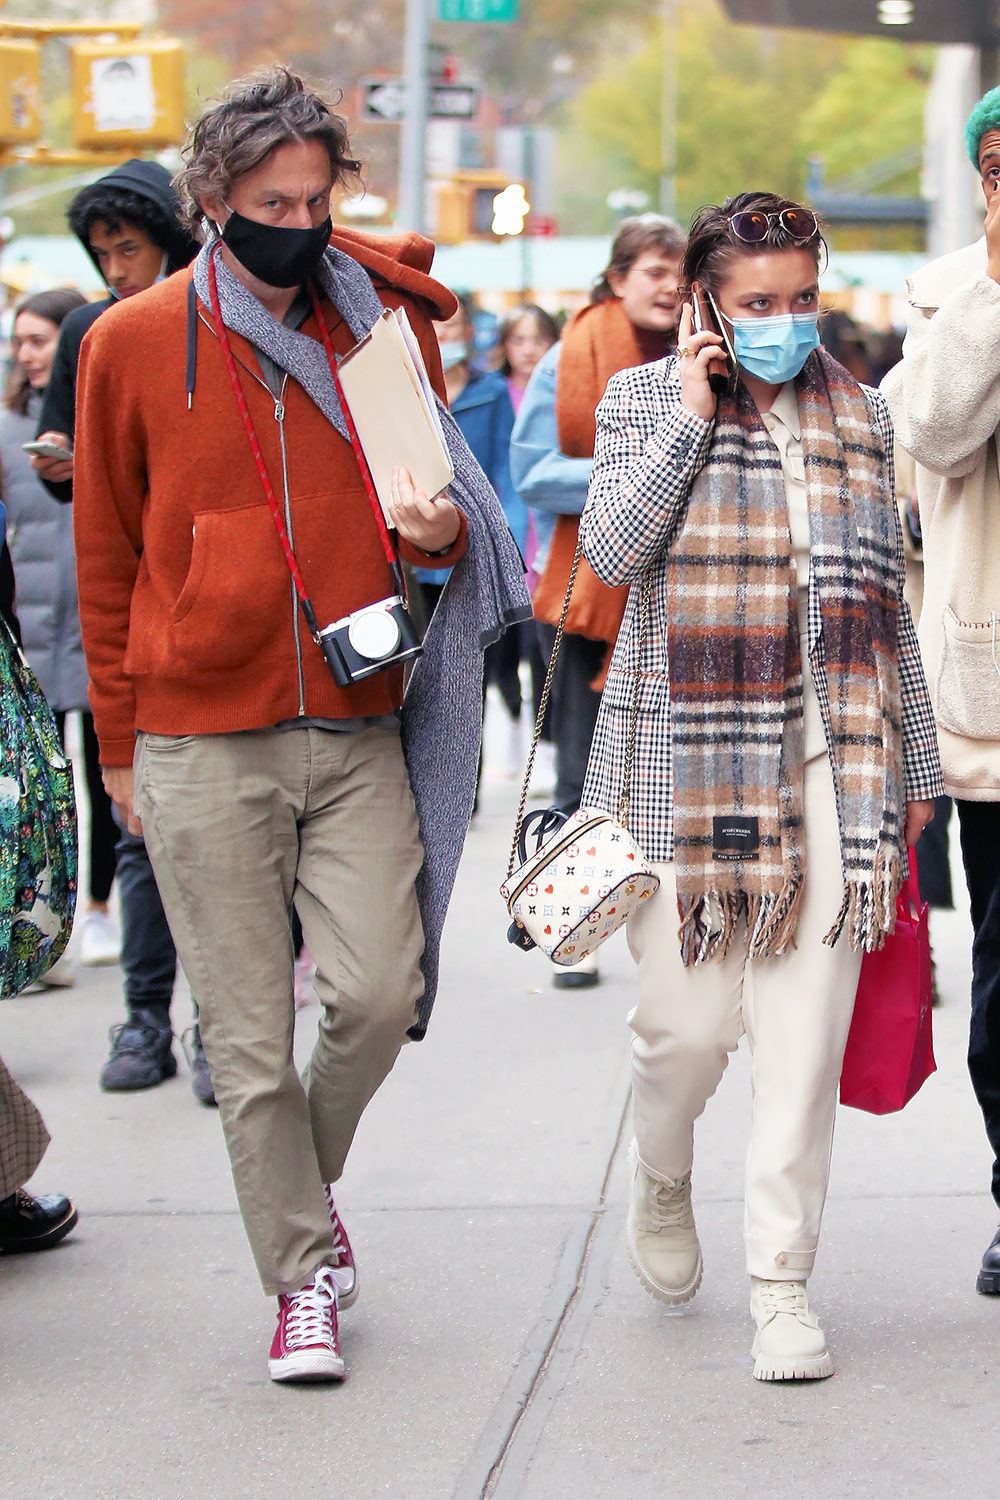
[[840, 849, 937, 1115]]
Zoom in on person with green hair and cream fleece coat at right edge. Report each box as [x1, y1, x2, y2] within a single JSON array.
[[882, 89, 1000, 1296]]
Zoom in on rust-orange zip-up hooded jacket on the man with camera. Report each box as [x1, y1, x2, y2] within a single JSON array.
[[73, 231, 466, 767]]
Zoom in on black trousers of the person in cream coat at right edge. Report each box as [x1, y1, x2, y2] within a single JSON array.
[[955, 803, 1000, 1206]]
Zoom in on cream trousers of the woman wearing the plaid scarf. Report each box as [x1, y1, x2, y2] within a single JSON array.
[[628, 756, 861, 1281]]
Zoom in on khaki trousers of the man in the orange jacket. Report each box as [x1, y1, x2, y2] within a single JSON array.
[[135, 728, 423, 1295]]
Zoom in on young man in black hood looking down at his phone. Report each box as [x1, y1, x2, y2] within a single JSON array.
[[31, 161, 214, 1106]]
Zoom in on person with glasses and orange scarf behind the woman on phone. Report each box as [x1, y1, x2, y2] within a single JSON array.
[[511, 213, 684, 989]]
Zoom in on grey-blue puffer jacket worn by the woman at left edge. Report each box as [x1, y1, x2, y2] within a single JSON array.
[[0, 396, 90, 711]]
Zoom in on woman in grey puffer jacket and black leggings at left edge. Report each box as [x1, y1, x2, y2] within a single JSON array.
[[0, 287, 120, 986]]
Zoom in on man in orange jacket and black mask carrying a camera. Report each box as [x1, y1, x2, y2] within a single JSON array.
[[76, 68, 528, 1382]]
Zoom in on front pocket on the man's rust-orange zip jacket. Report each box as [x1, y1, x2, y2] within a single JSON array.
[[169, 506, 294, 672]]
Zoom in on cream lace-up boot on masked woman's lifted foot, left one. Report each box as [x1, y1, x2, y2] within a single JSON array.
[[625, 1142, 702, 1307]]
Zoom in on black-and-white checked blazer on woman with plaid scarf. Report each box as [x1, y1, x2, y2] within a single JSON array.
[[580, 357, 943, 863]]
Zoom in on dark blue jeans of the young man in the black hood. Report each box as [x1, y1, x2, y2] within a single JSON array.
[[115, 815, 177, 1026]]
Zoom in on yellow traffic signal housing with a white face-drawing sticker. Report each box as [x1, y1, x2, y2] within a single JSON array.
[[69, 39, 184, 152]]
